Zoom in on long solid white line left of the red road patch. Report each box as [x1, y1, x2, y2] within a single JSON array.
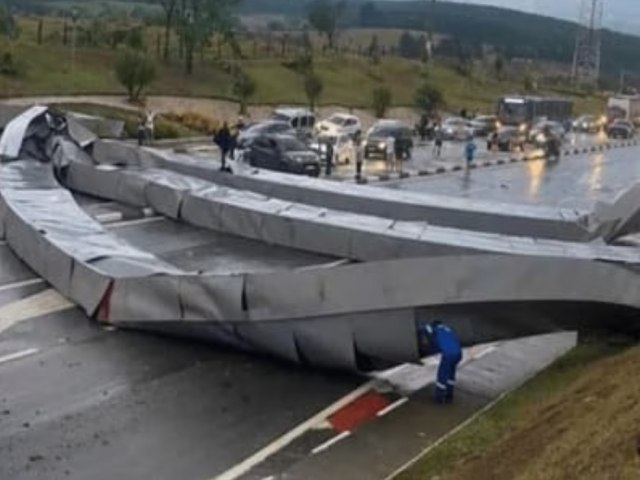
[[212, 381, 375, 480]]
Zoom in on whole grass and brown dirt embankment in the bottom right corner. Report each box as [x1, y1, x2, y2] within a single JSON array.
[[398, 341, 640, 480]]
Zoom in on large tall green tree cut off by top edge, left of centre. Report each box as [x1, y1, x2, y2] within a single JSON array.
[[176, 0, 237, 75]]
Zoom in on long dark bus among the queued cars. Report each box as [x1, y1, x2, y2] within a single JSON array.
[[498, 96, 573, 127]]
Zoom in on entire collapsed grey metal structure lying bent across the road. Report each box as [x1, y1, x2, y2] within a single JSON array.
[[0, 107, 640, 370]]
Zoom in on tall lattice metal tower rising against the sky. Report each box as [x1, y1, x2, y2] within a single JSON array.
[[573, 0, 604, 85]]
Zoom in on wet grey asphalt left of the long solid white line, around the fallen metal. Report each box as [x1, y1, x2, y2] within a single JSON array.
[[0, 199, 363, 480]]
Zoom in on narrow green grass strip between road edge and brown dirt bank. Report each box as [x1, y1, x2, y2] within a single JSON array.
[[397, 340, 622, 480]]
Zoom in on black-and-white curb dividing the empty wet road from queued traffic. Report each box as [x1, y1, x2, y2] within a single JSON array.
[[359, 140, 639, 184]]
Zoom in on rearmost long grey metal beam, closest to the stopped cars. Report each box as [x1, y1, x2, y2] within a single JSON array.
[[111, 142, 594, 241]]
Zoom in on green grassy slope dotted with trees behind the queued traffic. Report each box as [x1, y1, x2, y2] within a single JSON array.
[[0, 18, 602, 113]]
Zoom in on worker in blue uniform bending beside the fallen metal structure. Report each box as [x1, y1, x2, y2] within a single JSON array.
[[420, 321, 462, 403]]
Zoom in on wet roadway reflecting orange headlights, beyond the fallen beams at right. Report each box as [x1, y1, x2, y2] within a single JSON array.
[[380, 142, 640, 210]]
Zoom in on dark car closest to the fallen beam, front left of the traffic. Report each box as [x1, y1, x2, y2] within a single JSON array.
[[243, 135, 320, 177]]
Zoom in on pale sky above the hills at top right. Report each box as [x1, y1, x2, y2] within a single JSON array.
[[448, 0, 640, 35]]
